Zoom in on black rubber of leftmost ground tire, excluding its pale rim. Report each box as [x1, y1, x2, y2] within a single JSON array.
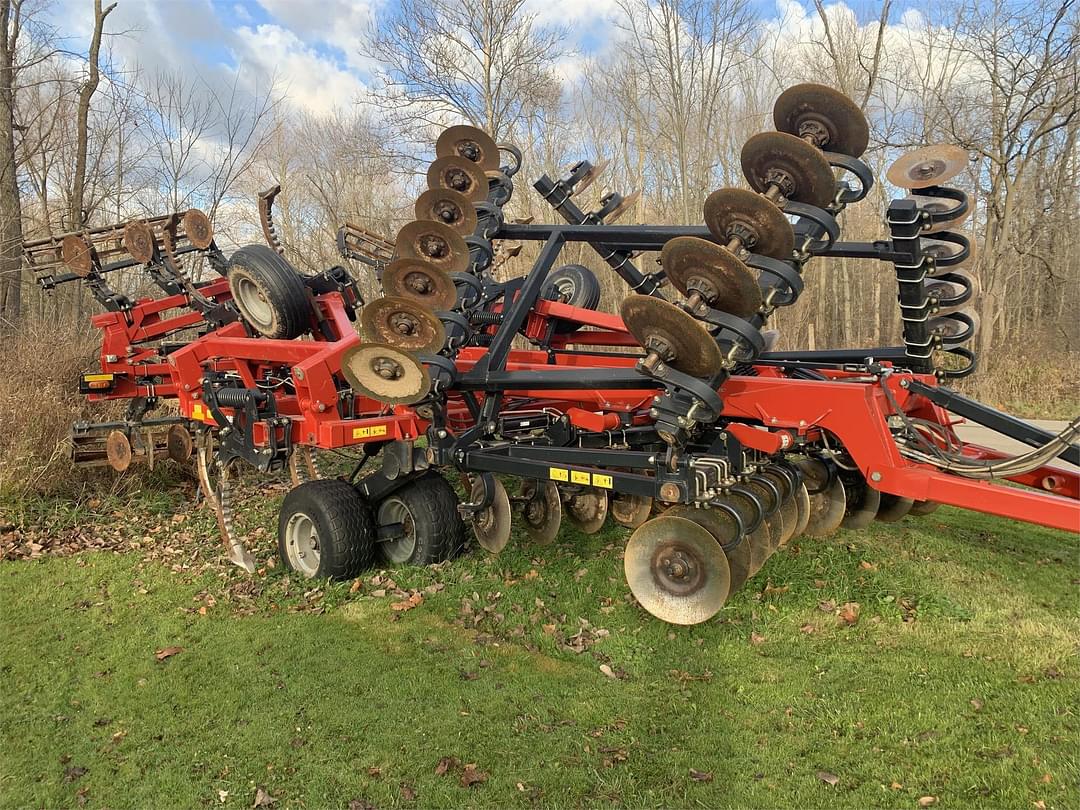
[[278, 478, 376, 580]]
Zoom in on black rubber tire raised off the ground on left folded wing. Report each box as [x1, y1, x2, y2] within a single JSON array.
[[226, 244, 311, 340]]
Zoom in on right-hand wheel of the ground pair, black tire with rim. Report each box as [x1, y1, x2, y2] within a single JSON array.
[[375, 473, 465, 565]]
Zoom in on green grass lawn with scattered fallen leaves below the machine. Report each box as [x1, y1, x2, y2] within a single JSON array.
[[0, 479, 1080, 809]]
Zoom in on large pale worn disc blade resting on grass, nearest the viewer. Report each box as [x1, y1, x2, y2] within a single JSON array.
[[623, 515, 731, 624]]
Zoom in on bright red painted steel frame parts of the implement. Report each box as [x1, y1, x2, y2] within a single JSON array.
[[84, 287, 1080, 540]]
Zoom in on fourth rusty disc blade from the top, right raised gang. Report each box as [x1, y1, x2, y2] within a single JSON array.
[[660, 237, 761, 318]]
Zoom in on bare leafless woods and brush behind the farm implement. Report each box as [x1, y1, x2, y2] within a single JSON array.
[[0, 0, 1080, 494]]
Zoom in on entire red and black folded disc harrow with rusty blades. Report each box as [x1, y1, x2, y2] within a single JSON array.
[[39, 84, 1080, 624]]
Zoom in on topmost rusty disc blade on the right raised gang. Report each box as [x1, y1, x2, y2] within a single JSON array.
[[772, 83, 870, 158]]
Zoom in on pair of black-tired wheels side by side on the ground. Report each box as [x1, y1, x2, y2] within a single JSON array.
[[278, 473, 465, 580]]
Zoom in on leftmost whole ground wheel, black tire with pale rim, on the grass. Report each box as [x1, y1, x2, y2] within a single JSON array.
[[278, 478, 375, 580]]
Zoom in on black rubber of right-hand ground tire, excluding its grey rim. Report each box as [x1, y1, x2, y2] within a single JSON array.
[[375, 472, 467, 565]]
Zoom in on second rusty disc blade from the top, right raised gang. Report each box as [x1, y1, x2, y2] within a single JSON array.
[[742, 132, 836, 208]]
